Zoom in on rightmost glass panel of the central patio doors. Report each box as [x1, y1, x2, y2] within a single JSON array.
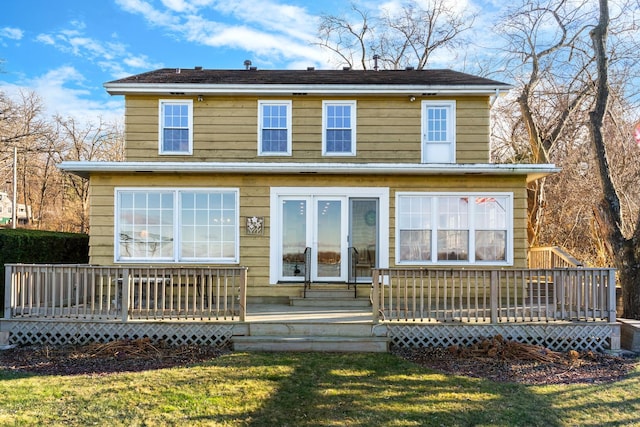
[[349, 198, 379, 282]]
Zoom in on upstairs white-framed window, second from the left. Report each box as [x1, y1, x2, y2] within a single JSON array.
[[258, 101, 291, 156]]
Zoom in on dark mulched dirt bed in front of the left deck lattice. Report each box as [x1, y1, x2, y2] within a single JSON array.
[[0, 339, 229, 375]]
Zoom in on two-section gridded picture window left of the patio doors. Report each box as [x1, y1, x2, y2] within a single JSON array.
[[116, 189, 239, 263]]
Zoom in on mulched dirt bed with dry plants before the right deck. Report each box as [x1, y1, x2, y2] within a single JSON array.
[[394, 337, 638, 385]]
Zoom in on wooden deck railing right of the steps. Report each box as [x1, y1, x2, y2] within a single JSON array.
[[372, 268, 616, 323]]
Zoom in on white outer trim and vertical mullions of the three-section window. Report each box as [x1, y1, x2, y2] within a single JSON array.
[[394, 191, 515, 266]]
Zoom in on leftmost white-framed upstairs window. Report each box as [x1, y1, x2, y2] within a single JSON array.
[[159, 99, 193, 154]]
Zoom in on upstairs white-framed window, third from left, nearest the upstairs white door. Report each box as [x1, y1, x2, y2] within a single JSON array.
[[322, 101, 356, 156]]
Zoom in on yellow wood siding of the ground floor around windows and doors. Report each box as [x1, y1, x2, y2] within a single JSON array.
[[90, 174, 527, 296]]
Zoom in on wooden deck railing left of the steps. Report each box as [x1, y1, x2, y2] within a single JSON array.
[[5, 264, 247, 322]]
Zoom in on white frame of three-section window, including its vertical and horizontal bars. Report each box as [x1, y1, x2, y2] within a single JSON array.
[[395, 192, 514, 266]]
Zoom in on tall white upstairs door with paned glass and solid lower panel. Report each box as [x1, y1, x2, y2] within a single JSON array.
[[422, 101, 456, 163]]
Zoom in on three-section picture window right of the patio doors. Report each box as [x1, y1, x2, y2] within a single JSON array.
[[396, 193, 512, 264]]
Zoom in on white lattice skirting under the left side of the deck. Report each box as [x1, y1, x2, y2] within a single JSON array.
[[2, 321, 234, 346]]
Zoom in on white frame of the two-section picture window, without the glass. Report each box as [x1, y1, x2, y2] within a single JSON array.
[[113, 187, 240, 264]]
